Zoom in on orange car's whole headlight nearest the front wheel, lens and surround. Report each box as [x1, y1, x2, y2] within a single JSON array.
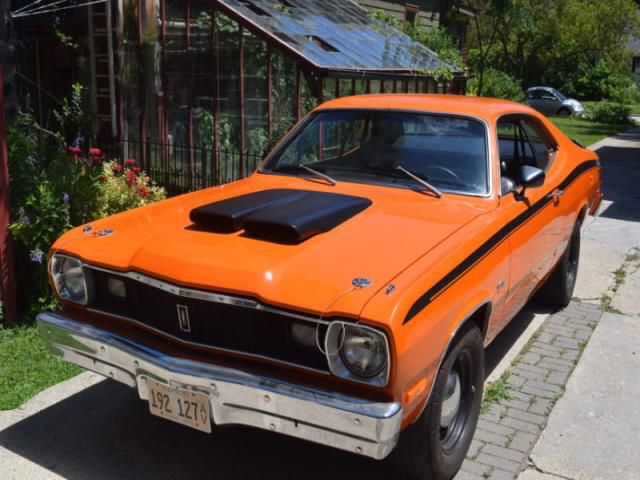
[[325, 322, 389, 386]]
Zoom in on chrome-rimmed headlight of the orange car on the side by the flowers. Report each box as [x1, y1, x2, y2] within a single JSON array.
[[49, 253, 93, 305]]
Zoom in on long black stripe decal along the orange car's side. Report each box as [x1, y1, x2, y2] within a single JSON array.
[[402, 160, 600, 324]]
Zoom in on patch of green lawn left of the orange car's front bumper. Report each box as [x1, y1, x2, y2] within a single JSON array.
[[0, 326, 82, 410]]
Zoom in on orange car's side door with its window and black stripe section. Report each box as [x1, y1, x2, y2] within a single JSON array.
[[497, 115, 563, 328]]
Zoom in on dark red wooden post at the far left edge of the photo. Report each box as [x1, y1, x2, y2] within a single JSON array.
[[0, 65, 16, 323]]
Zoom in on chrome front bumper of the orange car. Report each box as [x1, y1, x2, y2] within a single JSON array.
[[38, 313, 402, 459]]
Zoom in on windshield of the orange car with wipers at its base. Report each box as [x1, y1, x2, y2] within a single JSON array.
[[262, 110, 489, 195]]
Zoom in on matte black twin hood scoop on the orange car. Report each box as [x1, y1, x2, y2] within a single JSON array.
[[189, 189, 371, 244]]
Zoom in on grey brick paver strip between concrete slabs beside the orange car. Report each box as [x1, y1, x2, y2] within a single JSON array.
[[456, 302, 602, 480]]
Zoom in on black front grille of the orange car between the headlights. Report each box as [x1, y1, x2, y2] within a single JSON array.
[[89, 269, 328, 371]]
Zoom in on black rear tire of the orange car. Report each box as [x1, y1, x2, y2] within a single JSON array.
[[540, 223, 580, 308]]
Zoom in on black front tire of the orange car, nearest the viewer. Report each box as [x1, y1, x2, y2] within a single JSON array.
[[391, 324, 484, 480]]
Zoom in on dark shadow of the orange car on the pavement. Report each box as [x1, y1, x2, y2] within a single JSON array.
[[0, 304, 542, 480]]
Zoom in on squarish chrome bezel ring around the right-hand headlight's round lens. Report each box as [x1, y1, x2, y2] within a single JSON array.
[[324, 320, 391, 387]]
